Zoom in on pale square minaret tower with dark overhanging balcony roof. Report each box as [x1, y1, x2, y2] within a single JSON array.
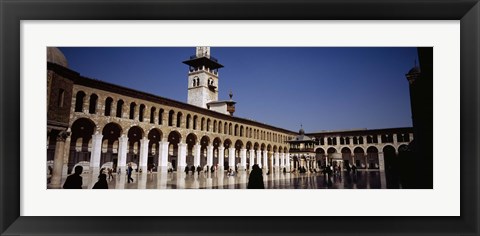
[[183, 47, 223, 109]]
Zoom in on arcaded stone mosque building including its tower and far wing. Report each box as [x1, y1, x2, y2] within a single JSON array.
[[47, 47, 413, 187]]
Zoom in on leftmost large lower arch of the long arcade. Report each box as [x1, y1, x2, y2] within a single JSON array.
[[67, 118, 97, 173]]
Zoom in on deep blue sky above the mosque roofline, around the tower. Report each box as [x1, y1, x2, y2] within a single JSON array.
[[60, 47, 418, 133]]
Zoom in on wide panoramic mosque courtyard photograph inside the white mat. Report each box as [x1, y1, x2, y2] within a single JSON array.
[[45, 46, 433, 190]]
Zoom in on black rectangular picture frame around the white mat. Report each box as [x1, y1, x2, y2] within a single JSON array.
[[0, 0, 480, 235]]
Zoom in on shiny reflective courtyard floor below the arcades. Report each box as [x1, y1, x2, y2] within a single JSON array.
[[48, 171, 386, 189]]
